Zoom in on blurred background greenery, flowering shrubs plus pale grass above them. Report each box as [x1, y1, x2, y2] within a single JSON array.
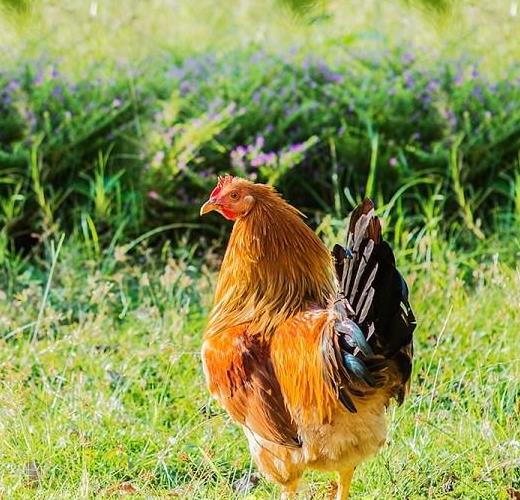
[[0, 0, 520, 261]]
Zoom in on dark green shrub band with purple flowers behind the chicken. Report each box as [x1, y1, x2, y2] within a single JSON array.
[[0, 50, 520, 254]]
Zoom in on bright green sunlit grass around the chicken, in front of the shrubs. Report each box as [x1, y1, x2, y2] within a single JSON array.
[[0, 231, 520, 499]]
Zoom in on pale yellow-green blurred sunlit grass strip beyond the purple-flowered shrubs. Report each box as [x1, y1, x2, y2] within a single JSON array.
[[0, 0, 520, 76]]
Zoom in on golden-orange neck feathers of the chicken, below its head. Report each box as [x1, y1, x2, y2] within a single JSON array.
[[206, 185, 335, 336]]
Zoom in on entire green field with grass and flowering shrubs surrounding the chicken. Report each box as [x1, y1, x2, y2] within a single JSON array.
[[0, 0, 520, 499]]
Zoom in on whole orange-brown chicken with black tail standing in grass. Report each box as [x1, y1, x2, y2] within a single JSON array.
[[200, 176, 415, 499]]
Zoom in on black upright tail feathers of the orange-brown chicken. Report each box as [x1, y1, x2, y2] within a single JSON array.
[[323, 199, 416, 411]]
